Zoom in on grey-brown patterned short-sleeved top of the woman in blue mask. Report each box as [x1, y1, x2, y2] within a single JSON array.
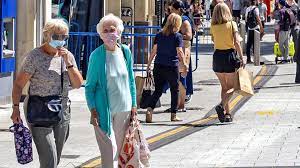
[[21, 48, 77, 96]]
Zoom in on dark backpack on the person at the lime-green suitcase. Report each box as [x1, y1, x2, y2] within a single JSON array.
[[281, 8, 296, 31]]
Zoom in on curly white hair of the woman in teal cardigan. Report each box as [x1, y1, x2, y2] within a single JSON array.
[[97, 13, 124, 36]]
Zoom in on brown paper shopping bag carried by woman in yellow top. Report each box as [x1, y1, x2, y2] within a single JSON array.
[[234, 68, 254, 96]]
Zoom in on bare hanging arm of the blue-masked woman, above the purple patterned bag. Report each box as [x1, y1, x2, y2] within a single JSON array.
[[10, 72, 32, 123]]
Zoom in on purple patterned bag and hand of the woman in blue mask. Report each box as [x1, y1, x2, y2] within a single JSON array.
[[9, 123, 33, 164]]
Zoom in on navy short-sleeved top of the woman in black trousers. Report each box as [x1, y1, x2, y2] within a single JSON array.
[[154, 32, 183, 67]]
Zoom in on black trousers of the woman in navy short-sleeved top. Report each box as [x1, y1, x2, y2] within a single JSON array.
[[148, 64, 179, 113]]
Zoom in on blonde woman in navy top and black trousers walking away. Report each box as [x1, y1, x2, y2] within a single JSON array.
[[146, 13, 188, 123]]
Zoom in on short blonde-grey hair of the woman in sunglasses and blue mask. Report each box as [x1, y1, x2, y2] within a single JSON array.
[[43, 19, 69, 43]]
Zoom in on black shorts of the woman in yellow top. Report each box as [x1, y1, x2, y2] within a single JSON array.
[[213, 49, 236, 73]]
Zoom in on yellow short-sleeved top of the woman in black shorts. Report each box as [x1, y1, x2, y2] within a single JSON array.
[[210, 21, 238, 50]]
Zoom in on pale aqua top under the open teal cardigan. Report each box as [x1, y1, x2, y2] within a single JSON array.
[[106, 48, 132, 113]]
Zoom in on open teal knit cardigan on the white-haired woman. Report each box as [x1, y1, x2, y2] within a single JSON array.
[[85, 45, 137, 136]]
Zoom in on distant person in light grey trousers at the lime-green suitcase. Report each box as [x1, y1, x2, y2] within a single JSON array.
[[278, 0, 292, 62]]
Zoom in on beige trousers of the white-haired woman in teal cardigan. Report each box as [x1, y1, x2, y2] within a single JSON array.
[[94, 112, 130, 168]]
